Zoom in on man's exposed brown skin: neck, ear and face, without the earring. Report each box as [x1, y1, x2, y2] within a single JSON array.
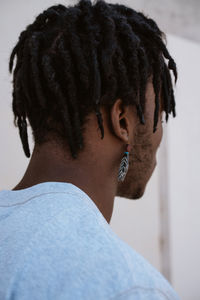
[[13, 77, 162, 223]]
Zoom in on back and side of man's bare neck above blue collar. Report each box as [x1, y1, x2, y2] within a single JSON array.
[[13, 144, 117, 223]]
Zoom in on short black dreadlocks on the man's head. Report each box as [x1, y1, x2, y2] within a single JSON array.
[[9, 0, 177, 158]]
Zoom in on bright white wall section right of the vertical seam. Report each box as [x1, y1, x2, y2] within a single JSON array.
[[168, 36, 200, 300]]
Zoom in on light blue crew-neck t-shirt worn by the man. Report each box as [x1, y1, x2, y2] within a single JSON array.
[[0, 182, 179, 300]]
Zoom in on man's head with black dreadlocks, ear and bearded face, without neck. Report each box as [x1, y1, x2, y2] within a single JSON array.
[[10, 0, 177, 198]]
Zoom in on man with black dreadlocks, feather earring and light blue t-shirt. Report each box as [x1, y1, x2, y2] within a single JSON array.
[[0, 0, 178, 300]]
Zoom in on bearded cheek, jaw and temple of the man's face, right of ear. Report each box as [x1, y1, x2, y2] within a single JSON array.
[[117, 77, 163, 199]]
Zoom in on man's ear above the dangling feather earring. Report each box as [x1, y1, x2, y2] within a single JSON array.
[[110, 99, 137, 144]]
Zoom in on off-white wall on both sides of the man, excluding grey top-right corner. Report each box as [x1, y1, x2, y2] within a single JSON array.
[[0, 0, 200, 300]]
